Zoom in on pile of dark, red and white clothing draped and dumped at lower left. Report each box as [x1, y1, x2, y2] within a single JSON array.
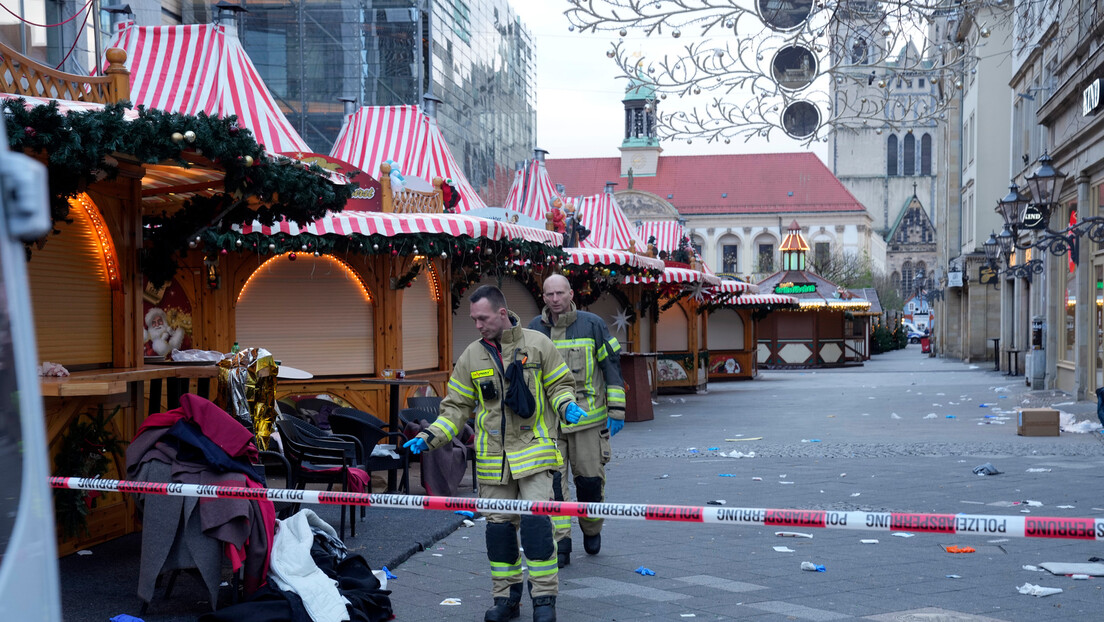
[[127, 394, 394, 622]]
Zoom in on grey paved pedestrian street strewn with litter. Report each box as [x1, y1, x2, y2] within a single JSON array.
[[389, 346, 1104, 622]]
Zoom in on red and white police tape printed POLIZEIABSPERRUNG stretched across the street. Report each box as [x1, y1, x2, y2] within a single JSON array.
[[50, 477, 1104, 540]]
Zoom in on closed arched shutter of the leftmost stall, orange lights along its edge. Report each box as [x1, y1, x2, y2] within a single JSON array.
[[26, 208, 112, 367]]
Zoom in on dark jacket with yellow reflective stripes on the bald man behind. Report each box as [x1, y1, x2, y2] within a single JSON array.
[[529, 303, 625, 432]]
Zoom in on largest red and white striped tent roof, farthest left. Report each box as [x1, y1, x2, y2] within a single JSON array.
[[104, 22, 310, 154]]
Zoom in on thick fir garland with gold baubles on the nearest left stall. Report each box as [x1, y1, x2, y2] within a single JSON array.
[[0, 98, 357, 285]]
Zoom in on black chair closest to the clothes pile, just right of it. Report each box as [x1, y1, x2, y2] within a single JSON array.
[[276, 415, 360, 539]]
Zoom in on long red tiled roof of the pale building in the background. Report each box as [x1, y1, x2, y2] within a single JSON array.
[[545, 154, 864, 214]]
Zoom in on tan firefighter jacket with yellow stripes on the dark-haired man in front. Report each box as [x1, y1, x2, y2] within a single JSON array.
[[410, 312, 575, 484]]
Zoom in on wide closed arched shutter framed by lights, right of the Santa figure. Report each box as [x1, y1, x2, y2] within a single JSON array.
[[235, 253, 375, 376]]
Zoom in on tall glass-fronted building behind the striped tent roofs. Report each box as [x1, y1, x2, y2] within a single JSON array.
[[241, 0, 537, 204]]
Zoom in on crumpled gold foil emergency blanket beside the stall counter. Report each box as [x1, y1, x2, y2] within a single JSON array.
[[219, 348, 279, 451]]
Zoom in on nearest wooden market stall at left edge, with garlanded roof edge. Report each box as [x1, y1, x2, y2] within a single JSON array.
[[0, 36, 348, 555]]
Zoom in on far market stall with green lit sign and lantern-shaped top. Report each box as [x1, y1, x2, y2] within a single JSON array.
[[756, 221, 870, 368]]
